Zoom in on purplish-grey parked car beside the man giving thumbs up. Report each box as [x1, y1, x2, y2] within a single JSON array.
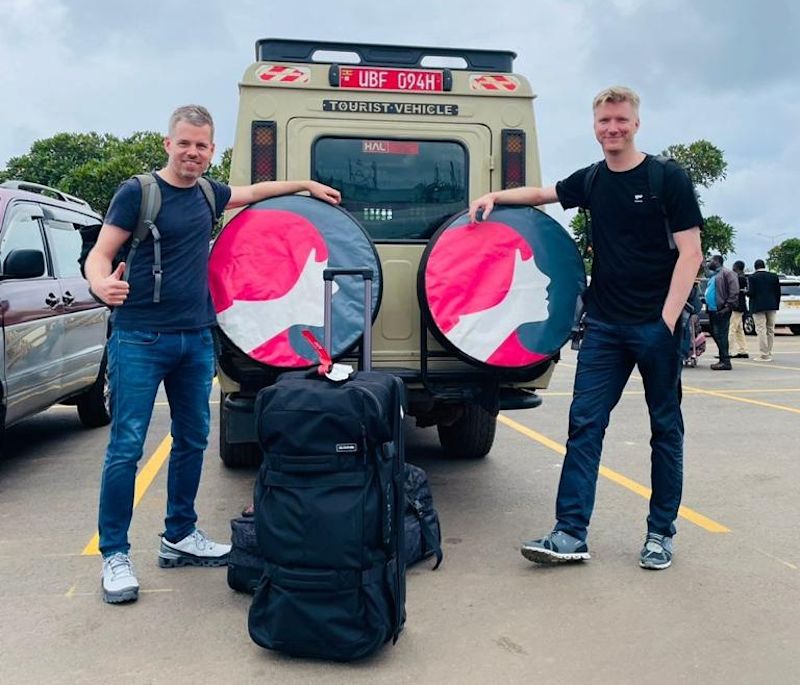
[[0, 181, 110, 455]]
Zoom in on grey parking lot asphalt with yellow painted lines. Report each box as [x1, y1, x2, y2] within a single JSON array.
[[0, 331, 800, 685]]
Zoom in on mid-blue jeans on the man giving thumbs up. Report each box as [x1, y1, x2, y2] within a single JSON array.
[[98, 329, 214, 557]]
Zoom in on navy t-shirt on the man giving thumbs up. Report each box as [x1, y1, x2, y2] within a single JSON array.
[[105, 174, 231, 333]]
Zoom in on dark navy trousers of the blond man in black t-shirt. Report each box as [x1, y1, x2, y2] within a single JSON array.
[[556, 319, 683, 540]]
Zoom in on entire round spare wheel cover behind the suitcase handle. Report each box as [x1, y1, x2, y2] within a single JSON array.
[[209, 195, 382, 368]]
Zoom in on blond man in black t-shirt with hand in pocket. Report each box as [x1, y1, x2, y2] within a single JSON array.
[[470, 86, 702, 569]]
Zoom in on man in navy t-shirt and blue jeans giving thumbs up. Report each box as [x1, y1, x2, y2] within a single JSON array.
[[85, 105, 341, 604]]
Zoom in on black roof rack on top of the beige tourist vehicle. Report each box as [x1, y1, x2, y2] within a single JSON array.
[[256, 38, 517, 72]]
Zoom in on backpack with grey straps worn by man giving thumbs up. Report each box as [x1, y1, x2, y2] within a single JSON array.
[[78, 174, 217, 303]]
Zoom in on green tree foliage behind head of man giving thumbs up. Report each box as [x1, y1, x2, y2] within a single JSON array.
[[0, 131, 231, 214]]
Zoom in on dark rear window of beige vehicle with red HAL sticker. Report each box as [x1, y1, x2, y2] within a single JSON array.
[[311, 137, 469, 241]]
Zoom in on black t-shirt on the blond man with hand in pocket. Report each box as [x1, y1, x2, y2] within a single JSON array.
[[556, 155, 703, 324]]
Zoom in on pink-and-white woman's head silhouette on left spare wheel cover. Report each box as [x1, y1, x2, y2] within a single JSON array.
[[209, 209, 328, 367]]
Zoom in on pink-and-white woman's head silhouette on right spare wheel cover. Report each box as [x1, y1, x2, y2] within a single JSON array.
[[425, 221, 550, 367]]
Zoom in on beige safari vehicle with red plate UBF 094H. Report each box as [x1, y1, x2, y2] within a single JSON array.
[[218, 39, 554, 465]]
